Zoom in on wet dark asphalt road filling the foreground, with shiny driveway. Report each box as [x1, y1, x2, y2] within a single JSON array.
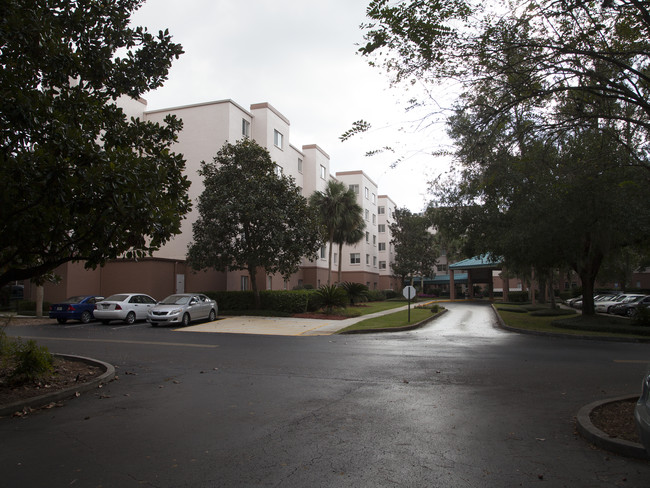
[[0, 303, 650, 488]]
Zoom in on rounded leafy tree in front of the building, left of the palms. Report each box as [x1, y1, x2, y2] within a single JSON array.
[[187, 139, 320, 306]]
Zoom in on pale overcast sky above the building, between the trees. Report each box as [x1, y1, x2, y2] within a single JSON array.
[[132, 0, 454, 212]]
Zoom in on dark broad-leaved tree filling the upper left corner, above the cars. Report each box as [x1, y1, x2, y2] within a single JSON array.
[[0, 0, 190, 285]]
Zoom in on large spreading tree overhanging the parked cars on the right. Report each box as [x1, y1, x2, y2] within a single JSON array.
[[361, 0, 650, 313]]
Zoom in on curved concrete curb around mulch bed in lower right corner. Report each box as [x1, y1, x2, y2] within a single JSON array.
[[576, 395, 650, 460]]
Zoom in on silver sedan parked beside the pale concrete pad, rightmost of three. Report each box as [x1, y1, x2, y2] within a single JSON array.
[[147, 293, 219, 327]]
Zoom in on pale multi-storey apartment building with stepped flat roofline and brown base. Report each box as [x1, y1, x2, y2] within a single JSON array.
[[33, 98, 395, 301]]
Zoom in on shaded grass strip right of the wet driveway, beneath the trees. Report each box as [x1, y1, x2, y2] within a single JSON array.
[[495, 304, 649, 339]]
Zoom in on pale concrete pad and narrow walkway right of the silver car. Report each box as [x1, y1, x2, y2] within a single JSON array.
[[176, 304, 414, 336]]
